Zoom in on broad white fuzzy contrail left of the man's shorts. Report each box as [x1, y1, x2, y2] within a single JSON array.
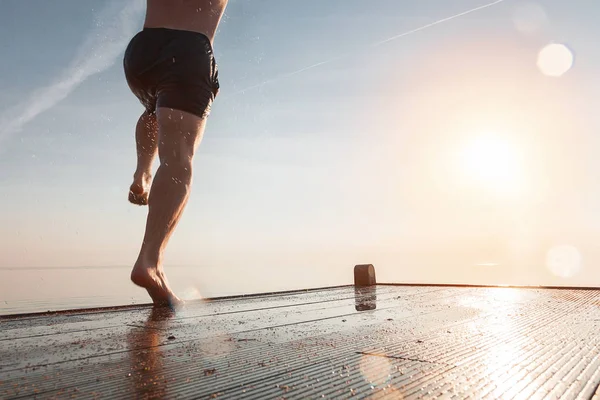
[[0, 0, 145, 148]]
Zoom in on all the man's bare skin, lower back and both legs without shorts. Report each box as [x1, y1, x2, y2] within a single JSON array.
[[129, 0, 227, 308]]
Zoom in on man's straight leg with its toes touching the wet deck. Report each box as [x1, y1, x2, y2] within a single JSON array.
[[131, 107, 206, 306]]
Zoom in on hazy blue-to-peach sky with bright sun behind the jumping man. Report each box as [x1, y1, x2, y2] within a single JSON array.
[[0, 0, 600, 310]]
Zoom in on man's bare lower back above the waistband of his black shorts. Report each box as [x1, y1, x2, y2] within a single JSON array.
[[144, 0, 228, 42]]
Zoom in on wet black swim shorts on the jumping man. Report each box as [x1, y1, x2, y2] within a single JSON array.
[[123, 28, 219, 118]]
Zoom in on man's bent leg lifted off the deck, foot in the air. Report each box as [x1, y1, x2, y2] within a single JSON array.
[[129, 111, 158, 205]]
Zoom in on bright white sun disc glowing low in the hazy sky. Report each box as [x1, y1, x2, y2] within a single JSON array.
[[460, 133, 522, 195]]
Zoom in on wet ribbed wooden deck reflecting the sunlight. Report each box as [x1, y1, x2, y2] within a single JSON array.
[[0, 285, 600, 399]]
